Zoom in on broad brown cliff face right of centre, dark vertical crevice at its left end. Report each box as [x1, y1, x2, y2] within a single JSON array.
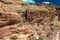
[[26, 5, 58, 23]]
